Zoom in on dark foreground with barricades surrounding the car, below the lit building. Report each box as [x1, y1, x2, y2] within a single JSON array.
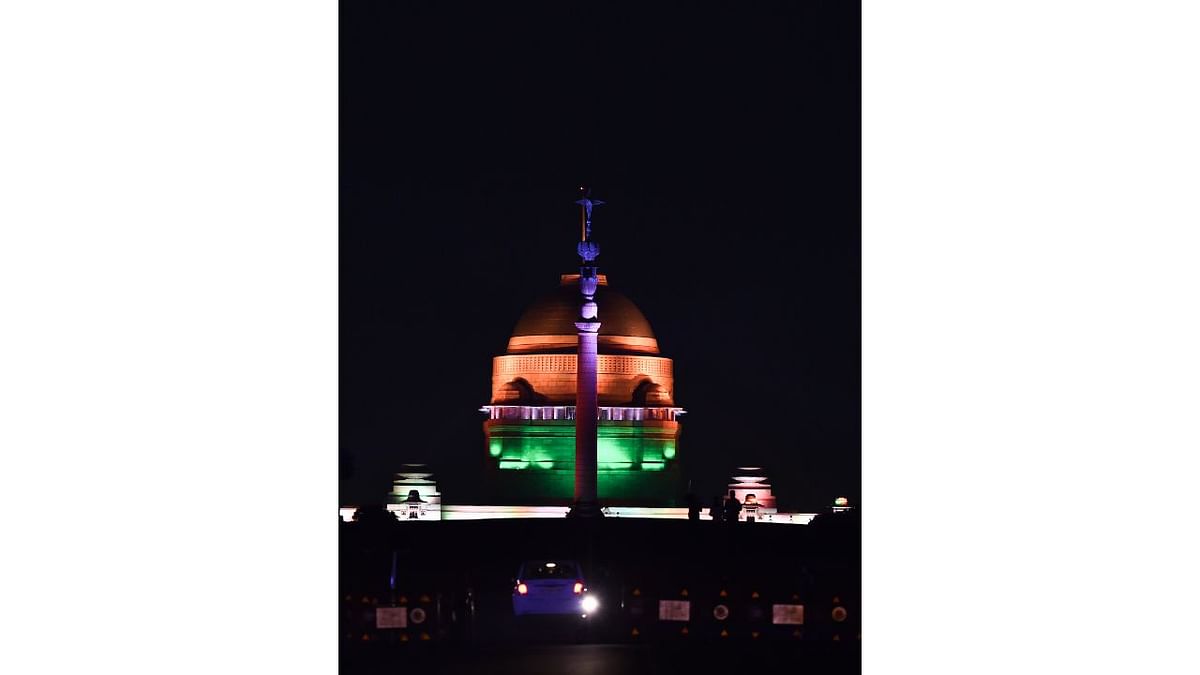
[[340, 513, 862, 674]]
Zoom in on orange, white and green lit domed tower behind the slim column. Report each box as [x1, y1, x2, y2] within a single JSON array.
[[481, 274, 684, 506]]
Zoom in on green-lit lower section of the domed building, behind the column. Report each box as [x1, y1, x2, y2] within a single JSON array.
[[484, 419, 684, 506]]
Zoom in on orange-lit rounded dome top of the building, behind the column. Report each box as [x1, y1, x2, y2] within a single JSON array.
[[508, 274, 659, 354]]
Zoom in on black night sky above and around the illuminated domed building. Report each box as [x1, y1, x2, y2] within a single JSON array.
[[340, 0, 862, 508]]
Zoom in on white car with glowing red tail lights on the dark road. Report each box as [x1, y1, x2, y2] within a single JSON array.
[[512, 560, 600, 619]]
